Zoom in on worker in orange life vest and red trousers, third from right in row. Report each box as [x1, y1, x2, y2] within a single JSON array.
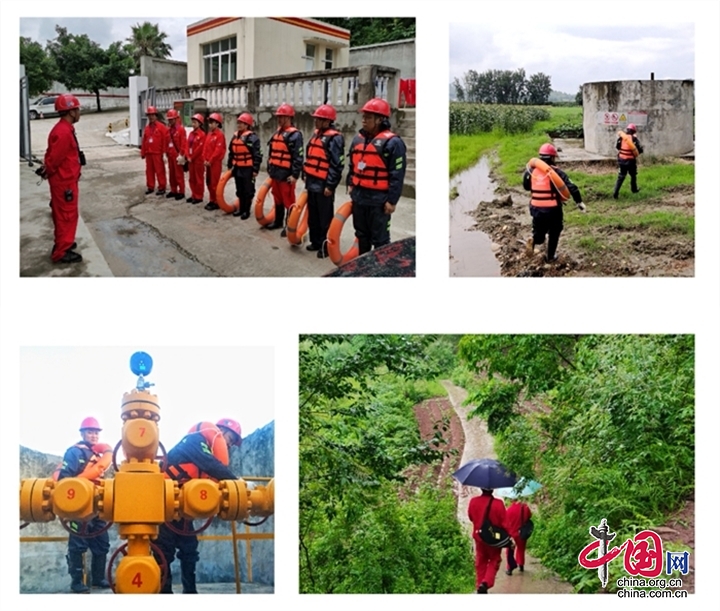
[[265, 104, 303, 233]]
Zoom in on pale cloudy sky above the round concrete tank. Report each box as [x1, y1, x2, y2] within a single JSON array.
[[450, 21, 695, 94]]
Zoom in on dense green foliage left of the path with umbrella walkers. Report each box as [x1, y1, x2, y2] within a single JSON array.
[[299, 335, 473, 593]]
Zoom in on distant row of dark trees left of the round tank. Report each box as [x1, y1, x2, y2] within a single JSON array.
[[453, 68, 552, 104]]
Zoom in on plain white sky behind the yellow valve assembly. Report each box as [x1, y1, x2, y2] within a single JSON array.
[[19, 346, 275, 455]]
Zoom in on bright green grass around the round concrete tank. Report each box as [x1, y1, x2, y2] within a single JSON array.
[[450, 105, 695, 258]]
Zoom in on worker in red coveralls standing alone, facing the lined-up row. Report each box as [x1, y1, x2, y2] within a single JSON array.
[[37, 93, 85, 263]]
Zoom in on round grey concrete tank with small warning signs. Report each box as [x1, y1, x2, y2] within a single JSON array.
[[583, 80, 695, 157]]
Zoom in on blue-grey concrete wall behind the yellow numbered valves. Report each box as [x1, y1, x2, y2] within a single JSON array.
[[20, 422, 275, 593]]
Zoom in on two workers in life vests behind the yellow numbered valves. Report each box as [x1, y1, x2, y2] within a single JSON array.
[[53, 417, 242, 594]]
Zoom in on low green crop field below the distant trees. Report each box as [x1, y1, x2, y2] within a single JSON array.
[[450, 102, 550, 135]]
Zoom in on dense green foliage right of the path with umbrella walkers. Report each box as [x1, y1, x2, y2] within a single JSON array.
[[459, 335, 695, 591]]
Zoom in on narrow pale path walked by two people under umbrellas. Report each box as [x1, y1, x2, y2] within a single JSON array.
[[442, 380, 572, 594]]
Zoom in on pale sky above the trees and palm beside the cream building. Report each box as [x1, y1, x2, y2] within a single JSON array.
[[20, 17, 200, 62]]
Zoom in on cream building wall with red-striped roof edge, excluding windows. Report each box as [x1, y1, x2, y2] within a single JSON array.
[[187, 17, 350, 85]]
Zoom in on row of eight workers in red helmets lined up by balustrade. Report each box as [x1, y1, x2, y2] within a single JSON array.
[[140, 98, 407, 258]]
